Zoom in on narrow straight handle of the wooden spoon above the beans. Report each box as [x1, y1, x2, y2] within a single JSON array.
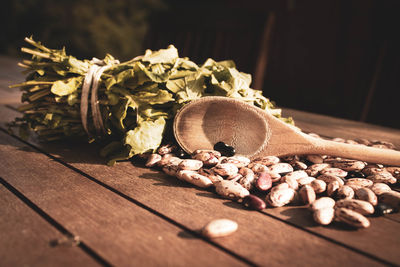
[[310, 138, 400, 166]]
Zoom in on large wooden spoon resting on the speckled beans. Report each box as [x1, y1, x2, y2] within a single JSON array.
[[173, 96, 400, 166]]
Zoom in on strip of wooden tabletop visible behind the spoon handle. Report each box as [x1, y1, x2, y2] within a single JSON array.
[[282, 108, 400, 149]]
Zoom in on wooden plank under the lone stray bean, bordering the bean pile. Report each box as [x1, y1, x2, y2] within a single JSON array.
[[0, 105, 390, 266]]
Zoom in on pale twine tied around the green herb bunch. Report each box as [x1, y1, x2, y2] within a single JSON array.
[[81, 58, 119, 137]]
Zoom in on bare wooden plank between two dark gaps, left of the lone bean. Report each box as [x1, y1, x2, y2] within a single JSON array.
[[0, 132, 246, 266]]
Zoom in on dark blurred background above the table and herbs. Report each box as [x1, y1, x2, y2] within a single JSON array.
[[0, 0, 400, 128]]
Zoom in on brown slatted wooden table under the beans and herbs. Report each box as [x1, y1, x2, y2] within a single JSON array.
[[0, 56, 400, 266]]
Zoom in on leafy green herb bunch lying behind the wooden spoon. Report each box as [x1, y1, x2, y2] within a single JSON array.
[[12, 38, 293, 165]]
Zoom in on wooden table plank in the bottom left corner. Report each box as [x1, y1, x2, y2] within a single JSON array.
[[0, 184, 101, 266]]
